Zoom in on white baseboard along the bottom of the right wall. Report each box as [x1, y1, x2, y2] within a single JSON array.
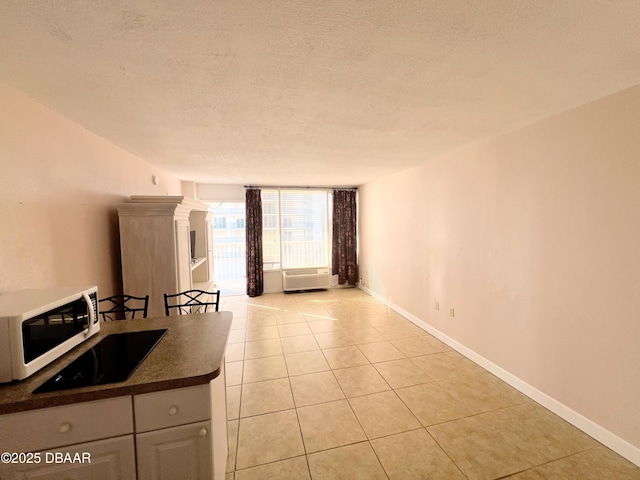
[[358, 285, 640, 466]]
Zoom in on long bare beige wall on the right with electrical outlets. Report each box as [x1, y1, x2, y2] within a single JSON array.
[[360, 87, 640, 462]]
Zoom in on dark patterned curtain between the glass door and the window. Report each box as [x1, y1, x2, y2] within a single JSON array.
[[245, 188, 264, 297]]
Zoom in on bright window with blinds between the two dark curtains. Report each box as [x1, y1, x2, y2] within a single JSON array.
[[262, 189, 332, 269]]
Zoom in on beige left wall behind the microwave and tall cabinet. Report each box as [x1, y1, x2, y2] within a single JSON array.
[[0, 83, 181, 296]]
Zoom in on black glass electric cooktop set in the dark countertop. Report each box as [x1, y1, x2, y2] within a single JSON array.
[[33, 328, 167, 393]]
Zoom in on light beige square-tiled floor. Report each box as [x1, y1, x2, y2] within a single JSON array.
[[221, 289, 640, 480]]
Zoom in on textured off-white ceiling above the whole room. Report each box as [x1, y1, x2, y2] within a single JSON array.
[[0, 0, 640, 185]]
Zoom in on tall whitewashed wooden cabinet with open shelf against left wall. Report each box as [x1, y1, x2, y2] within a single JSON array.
[[118, 195, 213, 317]]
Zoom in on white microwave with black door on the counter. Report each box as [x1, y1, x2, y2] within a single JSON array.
[[0, 286, 100, 383]]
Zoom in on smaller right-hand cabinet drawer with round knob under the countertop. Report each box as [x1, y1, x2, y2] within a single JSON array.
[[133, 384, 210, 433]]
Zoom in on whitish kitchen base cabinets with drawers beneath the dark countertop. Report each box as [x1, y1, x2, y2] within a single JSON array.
[[0, 376, 228, 480]]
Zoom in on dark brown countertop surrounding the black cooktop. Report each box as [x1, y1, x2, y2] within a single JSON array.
[[0, 312, 232, 415]]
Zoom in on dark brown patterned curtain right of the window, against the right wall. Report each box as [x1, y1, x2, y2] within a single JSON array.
[[331, 190, 358, 285]]
